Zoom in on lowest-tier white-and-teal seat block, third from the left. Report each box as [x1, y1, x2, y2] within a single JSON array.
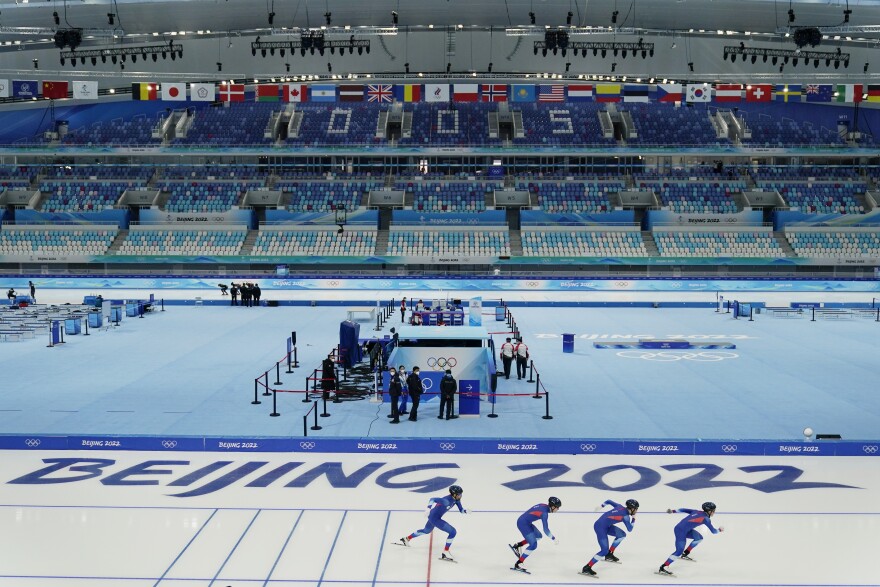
[[251, 226, 376, 257]]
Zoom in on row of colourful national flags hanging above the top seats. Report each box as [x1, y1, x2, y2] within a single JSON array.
[[0, 79, 880, 104]]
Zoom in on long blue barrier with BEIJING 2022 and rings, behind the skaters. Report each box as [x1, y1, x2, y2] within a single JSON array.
[[0, 434, 880, 457]]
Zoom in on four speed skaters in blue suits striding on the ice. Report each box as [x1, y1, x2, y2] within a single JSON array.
[[395, 485, 724, 577]]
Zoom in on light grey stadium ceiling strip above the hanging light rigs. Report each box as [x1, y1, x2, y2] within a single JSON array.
[[0, 0, 880, 48]]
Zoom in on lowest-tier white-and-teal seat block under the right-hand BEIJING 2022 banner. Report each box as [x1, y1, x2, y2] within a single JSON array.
[[654, 230, 785, 257]]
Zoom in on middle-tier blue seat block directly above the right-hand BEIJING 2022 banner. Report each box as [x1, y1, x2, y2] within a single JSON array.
[[638, 181, 746, 214]]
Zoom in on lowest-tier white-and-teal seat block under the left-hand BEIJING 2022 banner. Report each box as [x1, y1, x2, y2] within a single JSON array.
[[117, 227, 247, 255]]
